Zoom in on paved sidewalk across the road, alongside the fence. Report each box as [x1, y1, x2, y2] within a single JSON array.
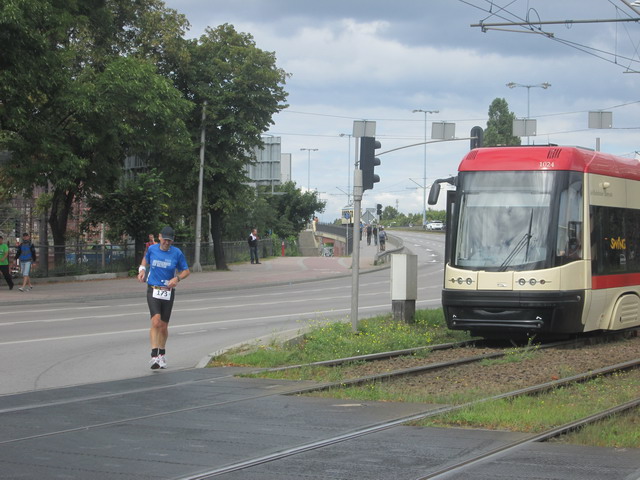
[[5, 242, 383, 305]]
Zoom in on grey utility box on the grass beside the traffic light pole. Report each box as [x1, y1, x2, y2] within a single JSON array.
[[391, 254, 418, 323]]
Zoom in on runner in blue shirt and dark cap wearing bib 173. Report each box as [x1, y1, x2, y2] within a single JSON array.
[[138, 226, 191, 370]]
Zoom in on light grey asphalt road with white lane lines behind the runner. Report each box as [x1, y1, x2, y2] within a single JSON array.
[[0, 232, 444, 394]]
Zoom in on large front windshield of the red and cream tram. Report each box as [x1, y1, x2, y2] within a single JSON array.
[[452, 171, 582, 271]]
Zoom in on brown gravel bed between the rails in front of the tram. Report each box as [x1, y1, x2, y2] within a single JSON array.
[[336, 337, 640, 395]]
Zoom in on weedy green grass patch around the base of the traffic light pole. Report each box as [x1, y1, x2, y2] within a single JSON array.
[[210, 310, 469, 368]]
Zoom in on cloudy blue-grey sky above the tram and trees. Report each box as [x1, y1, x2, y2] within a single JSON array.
[[165, 0, 640, 222]]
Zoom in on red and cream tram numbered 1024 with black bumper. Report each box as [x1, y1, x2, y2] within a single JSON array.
[[429, 146, 640, 338]]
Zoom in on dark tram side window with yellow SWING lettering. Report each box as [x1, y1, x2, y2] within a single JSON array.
[[591, 207, 640, 275]]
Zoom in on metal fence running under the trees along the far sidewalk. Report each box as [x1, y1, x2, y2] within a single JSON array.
[[15, 239, 282, 277]]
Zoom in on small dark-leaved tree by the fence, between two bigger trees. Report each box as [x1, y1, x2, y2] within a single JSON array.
[[87, 170, 169, 264]]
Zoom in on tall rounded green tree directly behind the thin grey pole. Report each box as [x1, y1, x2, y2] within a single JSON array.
[[176, 24, 287, 269]]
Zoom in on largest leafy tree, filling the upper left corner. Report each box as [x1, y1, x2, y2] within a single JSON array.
[[0, 0, 190, 261]]
